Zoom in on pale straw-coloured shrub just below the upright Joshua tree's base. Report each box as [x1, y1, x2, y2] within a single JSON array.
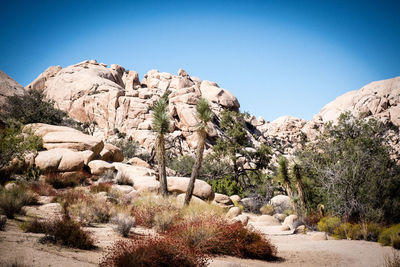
[[132, 195, 179, 228]]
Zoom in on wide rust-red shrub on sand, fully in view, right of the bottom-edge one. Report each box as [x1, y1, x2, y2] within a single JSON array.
[[167, 219, 277, 260]]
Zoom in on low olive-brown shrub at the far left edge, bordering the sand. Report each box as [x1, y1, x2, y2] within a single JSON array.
[[0, 185, 37, 219]]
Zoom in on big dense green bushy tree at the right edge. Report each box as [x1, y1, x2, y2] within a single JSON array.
[[300, 113, 400, 222]]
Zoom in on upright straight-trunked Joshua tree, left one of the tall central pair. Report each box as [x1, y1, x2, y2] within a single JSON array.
[[152, 97, 169, 196]]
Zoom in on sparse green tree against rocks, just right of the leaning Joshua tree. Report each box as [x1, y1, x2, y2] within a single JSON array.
[[213, 110, 271, 187]]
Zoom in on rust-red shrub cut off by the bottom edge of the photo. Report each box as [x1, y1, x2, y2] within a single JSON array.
[[99, 237, 208, 267]]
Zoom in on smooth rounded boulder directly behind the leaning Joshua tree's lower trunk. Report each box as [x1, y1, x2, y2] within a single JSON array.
[[167, 177, 214, 200]]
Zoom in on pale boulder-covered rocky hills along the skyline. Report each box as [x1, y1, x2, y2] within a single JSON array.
[[2, 60, 400, 161]]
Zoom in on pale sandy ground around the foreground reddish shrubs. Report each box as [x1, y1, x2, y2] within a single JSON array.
[[0, 211, 400, 267]]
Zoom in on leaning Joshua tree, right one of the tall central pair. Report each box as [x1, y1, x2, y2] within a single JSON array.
[[185, 98, 214, 205]]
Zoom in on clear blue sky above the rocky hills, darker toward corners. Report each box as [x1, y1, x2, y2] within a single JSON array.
[[0, 0, 400, 120]]
